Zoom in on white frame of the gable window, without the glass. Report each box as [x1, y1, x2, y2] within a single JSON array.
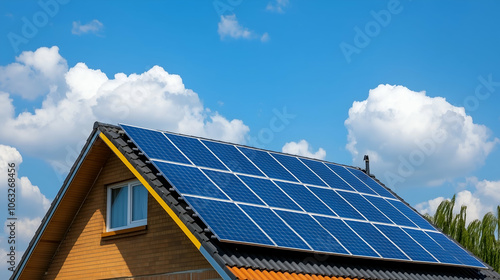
[[106, 180, 148, 231]]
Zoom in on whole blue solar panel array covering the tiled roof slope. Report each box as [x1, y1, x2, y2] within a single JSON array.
[[121, 125, 486, 268]]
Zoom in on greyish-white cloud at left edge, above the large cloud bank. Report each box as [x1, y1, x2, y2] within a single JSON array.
[[0, 47, 68, 100]]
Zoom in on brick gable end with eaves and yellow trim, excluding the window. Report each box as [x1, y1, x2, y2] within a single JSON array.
[[11, 127, 227, 279]]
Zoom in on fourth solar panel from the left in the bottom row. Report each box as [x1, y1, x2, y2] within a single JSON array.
[[315, 216, 379, 257]]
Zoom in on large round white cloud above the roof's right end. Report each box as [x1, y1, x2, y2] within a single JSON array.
[[345, 85, 500, 187]]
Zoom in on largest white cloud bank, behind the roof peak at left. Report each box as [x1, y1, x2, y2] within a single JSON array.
[[0, 47, 249, 173]]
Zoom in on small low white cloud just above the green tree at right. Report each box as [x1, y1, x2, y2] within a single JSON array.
[[415, 177, 500, 223]]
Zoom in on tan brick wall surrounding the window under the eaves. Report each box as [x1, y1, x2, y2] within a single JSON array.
[[28, 145, 215, 279]]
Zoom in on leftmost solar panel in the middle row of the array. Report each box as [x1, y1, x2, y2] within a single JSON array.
[[153, 161, 228, 199]]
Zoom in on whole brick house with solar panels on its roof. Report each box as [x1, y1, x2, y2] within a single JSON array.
[[11, 122, 500, 280]]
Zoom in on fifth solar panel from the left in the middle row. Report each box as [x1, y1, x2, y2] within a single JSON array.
[[309, 187, 365, 220]]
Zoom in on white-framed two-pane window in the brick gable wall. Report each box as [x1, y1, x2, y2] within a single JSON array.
[[106, 181, 148, 231]]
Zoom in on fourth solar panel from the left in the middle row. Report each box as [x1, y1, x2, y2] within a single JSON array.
[[276, 181, 336, 216]]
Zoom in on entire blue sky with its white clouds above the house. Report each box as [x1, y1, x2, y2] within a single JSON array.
[[0, 0, 500, 276]]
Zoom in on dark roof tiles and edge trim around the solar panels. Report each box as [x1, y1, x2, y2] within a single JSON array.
[[11, 123, 500, 279]]
